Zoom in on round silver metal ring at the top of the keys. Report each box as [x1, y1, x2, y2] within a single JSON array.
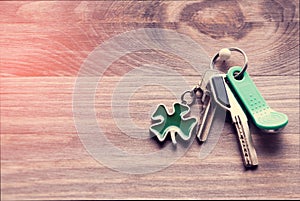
[[210, 47, 248, 80]]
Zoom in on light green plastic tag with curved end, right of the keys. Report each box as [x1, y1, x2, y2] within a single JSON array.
[[227, 66, 288, 132]]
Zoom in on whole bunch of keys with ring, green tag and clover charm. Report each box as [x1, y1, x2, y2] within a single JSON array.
[[150, 47, 288, 168]]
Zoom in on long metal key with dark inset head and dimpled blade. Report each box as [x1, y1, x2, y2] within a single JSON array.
[[210, 74, 258, 168]]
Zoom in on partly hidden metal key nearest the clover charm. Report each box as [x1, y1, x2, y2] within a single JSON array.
[[197, 70, 219, 142]]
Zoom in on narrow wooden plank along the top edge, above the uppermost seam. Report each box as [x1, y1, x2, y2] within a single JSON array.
[[0, 0, 299, 24]]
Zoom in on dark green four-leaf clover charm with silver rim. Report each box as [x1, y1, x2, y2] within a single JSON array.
[[150, 103, 197, 145]]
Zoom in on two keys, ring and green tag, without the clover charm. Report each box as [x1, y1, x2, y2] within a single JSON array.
[[196, 48, 288, 168]]
